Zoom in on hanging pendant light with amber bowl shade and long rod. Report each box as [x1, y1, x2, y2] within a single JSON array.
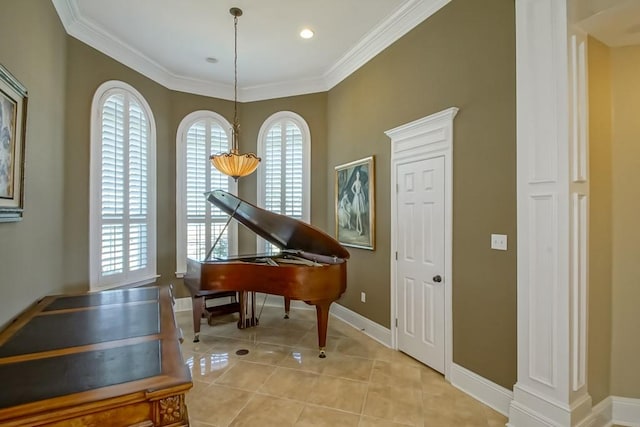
[[210, 7, 261, 181]]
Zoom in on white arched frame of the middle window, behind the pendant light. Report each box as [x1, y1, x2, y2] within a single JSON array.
[[175, 110, 238, 279]]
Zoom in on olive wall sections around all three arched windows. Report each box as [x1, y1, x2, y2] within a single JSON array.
[[64, 41, 326, 297]]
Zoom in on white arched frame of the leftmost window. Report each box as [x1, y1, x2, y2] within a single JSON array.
[[89, 80, 160, 291]]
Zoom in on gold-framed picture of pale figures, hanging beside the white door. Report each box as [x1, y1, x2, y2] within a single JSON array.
[[335, 156, 376, 250]]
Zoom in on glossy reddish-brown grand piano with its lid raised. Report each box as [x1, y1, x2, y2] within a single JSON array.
[[184, 190, 349, 358]]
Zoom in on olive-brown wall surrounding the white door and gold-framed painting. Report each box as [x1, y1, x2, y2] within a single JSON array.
[[326, 0, 516, 389]]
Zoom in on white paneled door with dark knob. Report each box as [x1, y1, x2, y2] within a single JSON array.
[[396, 157, 447, 373]]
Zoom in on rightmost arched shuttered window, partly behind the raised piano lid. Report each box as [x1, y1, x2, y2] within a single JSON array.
[[258, 111, 311, 253]]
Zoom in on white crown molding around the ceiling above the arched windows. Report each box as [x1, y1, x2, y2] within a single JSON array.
[[51, 0, 451, 102]]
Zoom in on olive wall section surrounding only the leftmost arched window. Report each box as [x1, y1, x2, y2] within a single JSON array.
[[64, 37, 172, 290]]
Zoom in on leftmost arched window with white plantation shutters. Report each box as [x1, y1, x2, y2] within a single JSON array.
[[89, 81, 157, 289]]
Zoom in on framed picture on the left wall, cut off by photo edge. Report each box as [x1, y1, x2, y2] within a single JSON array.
[[0, 65, 27, 222]]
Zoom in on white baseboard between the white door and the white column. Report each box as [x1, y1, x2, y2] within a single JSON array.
[[449, 363, 513, 416]]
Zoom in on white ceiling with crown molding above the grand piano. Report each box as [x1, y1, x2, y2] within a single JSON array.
[[52, 0, 450, 101]]
